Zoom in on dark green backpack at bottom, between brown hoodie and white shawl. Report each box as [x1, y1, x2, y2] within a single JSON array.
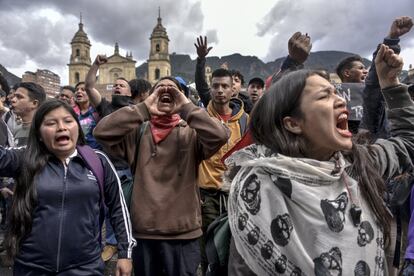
[[205, 213, 231, 276]]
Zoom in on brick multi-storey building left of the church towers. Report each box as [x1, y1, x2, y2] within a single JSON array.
[[22, 69, 60, 98]]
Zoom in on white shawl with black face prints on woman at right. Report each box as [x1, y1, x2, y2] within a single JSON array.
[[224, 144, 387, 276]]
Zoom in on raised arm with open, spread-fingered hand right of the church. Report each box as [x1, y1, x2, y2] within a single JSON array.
[[194, 36, 213, 106]]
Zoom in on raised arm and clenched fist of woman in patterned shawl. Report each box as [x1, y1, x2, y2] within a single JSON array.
[[369, 44, 414, 179]]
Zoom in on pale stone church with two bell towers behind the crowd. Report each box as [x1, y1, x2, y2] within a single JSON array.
[[68, 10, 171, 89]]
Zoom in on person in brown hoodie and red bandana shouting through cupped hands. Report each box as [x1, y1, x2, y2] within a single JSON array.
[[94, 77, 228, 275]]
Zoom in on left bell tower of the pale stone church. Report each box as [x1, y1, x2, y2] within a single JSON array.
[[68, 14, 91, 86]]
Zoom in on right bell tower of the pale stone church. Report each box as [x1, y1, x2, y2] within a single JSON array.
[[148, 8, 171, 85]]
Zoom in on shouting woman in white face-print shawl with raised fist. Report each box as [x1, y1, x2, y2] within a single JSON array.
[[226, 45, 414, 275]]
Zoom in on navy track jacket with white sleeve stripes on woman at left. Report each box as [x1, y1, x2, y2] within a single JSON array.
[[0, 147, 135, 272]]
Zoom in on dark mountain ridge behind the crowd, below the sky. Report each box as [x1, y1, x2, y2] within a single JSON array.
[[136, 51, 371, 83]]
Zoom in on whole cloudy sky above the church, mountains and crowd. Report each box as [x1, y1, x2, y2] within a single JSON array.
[[0, 0, 414, 85]]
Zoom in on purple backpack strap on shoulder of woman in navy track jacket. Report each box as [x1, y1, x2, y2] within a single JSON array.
[[76, 145, 105, 239]]
